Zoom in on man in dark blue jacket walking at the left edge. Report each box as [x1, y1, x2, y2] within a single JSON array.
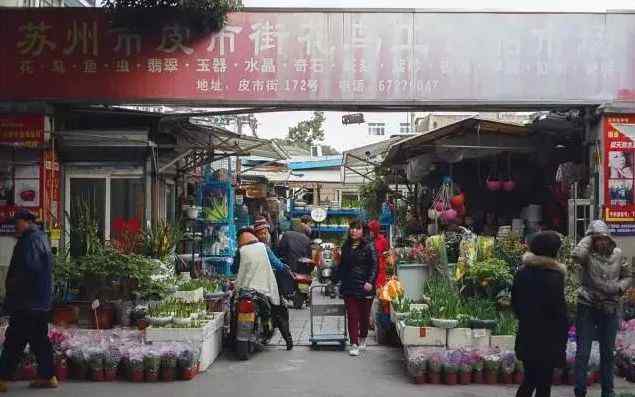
[[0, 209, 58, 392]]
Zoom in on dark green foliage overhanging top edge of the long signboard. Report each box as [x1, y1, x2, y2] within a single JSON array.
[[104, 0, 242, 34]]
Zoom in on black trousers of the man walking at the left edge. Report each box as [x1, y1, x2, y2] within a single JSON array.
[[0, 311, 54, 380]]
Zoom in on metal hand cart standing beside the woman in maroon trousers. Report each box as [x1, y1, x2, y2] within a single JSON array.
[[309, 284, 348, 350]]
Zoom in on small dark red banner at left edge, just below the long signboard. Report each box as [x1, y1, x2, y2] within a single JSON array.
[[0, 116, 44, 147]]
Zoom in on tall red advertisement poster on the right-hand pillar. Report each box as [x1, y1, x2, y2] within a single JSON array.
[[604, 115, 635, 236]]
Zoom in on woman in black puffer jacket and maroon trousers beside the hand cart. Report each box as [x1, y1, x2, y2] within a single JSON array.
[[337, 221, 377, 356]]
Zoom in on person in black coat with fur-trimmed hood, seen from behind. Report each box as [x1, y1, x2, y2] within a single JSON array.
[[512, 231, 568, 397]]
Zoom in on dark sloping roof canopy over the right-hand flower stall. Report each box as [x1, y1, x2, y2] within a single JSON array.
[[383, 117, 536, 166]]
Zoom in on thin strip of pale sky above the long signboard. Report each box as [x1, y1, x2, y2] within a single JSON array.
[[243, 0, 635, 11]]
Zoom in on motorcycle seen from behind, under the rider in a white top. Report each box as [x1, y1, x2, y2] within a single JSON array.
[[232, 289, 274, 361]]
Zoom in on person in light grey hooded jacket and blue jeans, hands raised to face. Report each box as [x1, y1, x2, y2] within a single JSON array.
[[572, 220, 632, 397]]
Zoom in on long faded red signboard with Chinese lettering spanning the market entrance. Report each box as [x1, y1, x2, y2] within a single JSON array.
[[0, 8, 635, 106]]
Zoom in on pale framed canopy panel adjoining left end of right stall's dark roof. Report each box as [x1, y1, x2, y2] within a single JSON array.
[[341, 135, 410, 183]]
